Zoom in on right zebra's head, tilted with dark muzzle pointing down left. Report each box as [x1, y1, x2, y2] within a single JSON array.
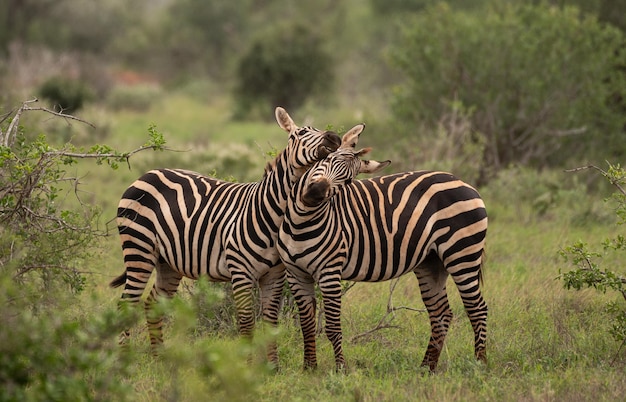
[[300, 124, 391, 207]]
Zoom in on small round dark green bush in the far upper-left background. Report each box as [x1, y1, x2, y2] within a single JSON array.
[[39, 76, 93, 112]]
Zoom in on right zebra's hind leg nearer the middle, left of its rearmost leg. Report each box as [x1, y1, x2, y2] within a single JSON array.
[[415, 254, 452, 371]]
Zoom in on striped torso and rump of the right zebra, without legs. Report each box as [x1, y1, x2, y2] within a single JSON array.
[[332, 171, 487, 282]]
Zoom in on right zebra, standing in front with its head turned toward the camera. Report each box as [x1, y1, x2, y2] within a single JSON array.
[[278, 127, 487, 371]]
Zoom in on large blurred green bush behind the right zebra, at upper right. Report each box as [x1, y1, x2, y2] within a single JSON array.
[[392, 3, 626, 178]]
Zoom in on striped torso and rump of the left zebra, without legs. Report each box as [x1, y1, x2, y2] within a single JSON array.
[[117, 169, 256, 281]]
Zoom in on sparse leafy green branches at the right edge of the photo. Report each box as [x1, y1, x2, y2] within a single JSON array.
[[560, 164, 626, 358]]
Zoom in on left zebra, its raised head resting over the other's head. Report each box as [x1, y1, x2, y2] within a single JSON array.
[[110, 107, 341, 363]]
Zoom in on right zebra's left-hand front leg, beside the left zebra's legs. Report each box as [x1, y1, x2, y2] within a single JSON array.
[[287, 270, 317, 370]]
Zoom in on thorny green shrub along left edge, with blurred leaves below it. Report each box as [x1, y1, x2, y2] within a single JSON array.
[[0, 101, 165, 401]]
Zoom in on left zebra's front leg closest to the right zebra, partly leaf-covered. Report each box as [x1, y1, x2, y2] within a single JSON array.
[[259, 263, 285, 368]]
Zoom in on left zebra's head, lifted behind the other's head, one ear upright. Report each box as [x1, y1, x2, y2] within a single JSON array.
[[275, 107, 341, 181]]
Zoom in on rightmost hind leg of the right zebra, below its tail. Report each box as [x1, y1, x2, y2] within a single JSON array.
[[448, 258, 488, 363]]
